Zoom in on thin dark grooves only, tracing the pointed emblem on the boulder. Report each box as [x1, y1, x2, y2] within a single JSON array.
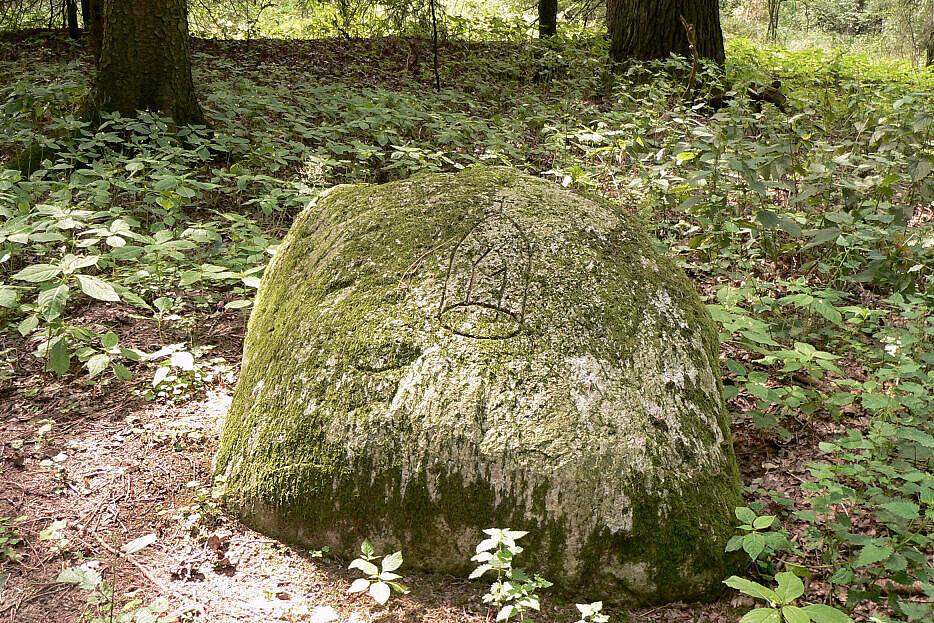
[[438, 197, 532, 339]]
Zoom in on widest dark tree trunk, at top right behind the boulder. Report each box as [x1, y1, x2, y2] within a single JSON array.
[[607, 0, 726, 65]]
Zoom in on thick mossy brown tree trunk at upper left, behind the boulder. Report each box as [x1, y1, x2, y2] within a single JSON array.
[[86, 0, 204, 124]]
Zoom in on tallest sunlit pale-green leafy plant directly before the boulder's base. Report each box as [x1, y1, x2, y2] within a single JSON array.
[[470, 528, 552, 621]]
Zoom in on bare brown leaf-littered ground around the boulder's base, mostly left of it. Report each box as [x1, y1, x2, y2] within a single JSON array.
[[0, 292, 830, 623]]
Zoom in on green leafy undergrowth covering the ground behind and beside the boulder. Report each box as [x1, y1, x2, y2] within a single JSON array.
[[0, 26, 934, 621]]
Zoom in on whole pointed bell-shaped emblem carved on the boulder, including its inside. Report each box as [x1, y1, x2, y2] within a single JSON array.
[[438, 198, 532, 339]]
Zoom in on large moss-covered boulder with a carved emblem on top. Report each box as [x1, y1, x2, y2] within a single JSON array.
[[217, 168, 740, 603]]
